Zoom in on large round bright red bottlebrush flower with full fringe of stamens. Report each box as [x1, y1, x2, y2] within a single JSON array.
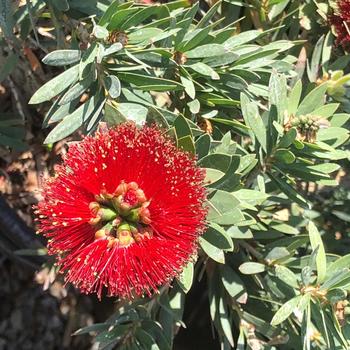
[[36, 123, 207, 298]]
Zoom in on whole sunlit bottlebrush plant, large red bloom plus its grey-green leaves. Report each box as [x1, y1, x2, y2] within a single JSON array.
[[24, 0, 350, 350]]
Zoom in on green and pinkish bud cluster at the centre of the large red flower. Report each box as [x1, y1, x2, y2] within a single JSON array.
[[89, 181, 153, 248]]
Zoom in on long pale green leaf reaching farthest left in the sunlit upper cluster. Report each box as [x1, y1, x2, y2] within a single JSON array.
[[28, 65, 79, 104]]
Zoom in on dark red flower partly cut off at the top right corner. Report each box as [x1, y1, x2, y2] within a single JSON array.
[[329, 0, 350, 50]]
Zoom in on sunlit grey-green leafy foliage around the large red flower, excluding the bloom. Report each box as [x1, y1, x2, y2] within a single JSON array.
[[31, 0, 350, 350]]
